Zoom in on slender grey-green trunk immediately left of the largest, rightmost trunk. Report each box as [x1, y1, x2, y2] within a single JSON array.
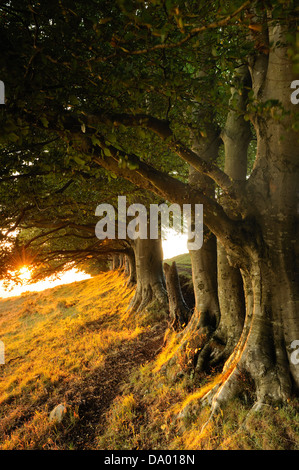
[[210, 66, 252, 366]]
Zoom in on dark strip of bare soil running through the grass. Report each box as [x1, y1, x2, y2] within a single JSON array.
[[60, 324, 167, 450]]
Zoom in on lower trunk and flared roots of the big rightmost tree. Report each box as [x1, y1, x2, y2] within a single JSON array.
[[206, 256, 299, 410]]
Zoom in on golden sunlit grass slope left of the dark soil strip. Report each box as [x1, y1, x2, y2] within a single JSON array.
[[0, 270, 142, 449]]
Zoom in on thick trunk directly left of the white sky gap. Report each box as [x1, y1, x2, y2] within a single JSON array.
[[130, 238, 168, 318]]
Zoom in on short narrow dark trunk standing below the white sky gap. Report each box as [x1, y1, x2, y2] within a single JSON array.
[[164, 262, 191, 331]]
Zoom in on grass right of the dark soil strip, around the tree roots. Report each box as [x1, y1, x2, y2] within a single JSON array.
[[98, 316, 299, 450]]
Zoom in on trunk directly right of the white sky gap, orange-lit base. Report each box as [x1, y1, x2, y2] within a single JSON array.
[[162, 124, 220, 370]]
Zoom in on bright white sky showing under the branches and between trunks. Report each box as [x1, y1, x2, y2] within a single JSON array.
[[0, 230, 188, 299]]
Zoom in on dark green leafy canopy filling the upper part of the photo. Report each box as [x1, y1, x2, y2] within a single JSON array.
[[0, 0, 296, 260]]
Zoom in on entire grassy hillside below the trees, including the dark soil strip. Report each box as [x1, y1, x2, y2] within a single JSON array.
[[0, 266, 299, 450]]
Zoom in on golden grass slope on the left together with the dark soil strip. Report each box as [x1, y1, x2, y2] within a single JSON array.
[[0, 272, 165, 449]]
